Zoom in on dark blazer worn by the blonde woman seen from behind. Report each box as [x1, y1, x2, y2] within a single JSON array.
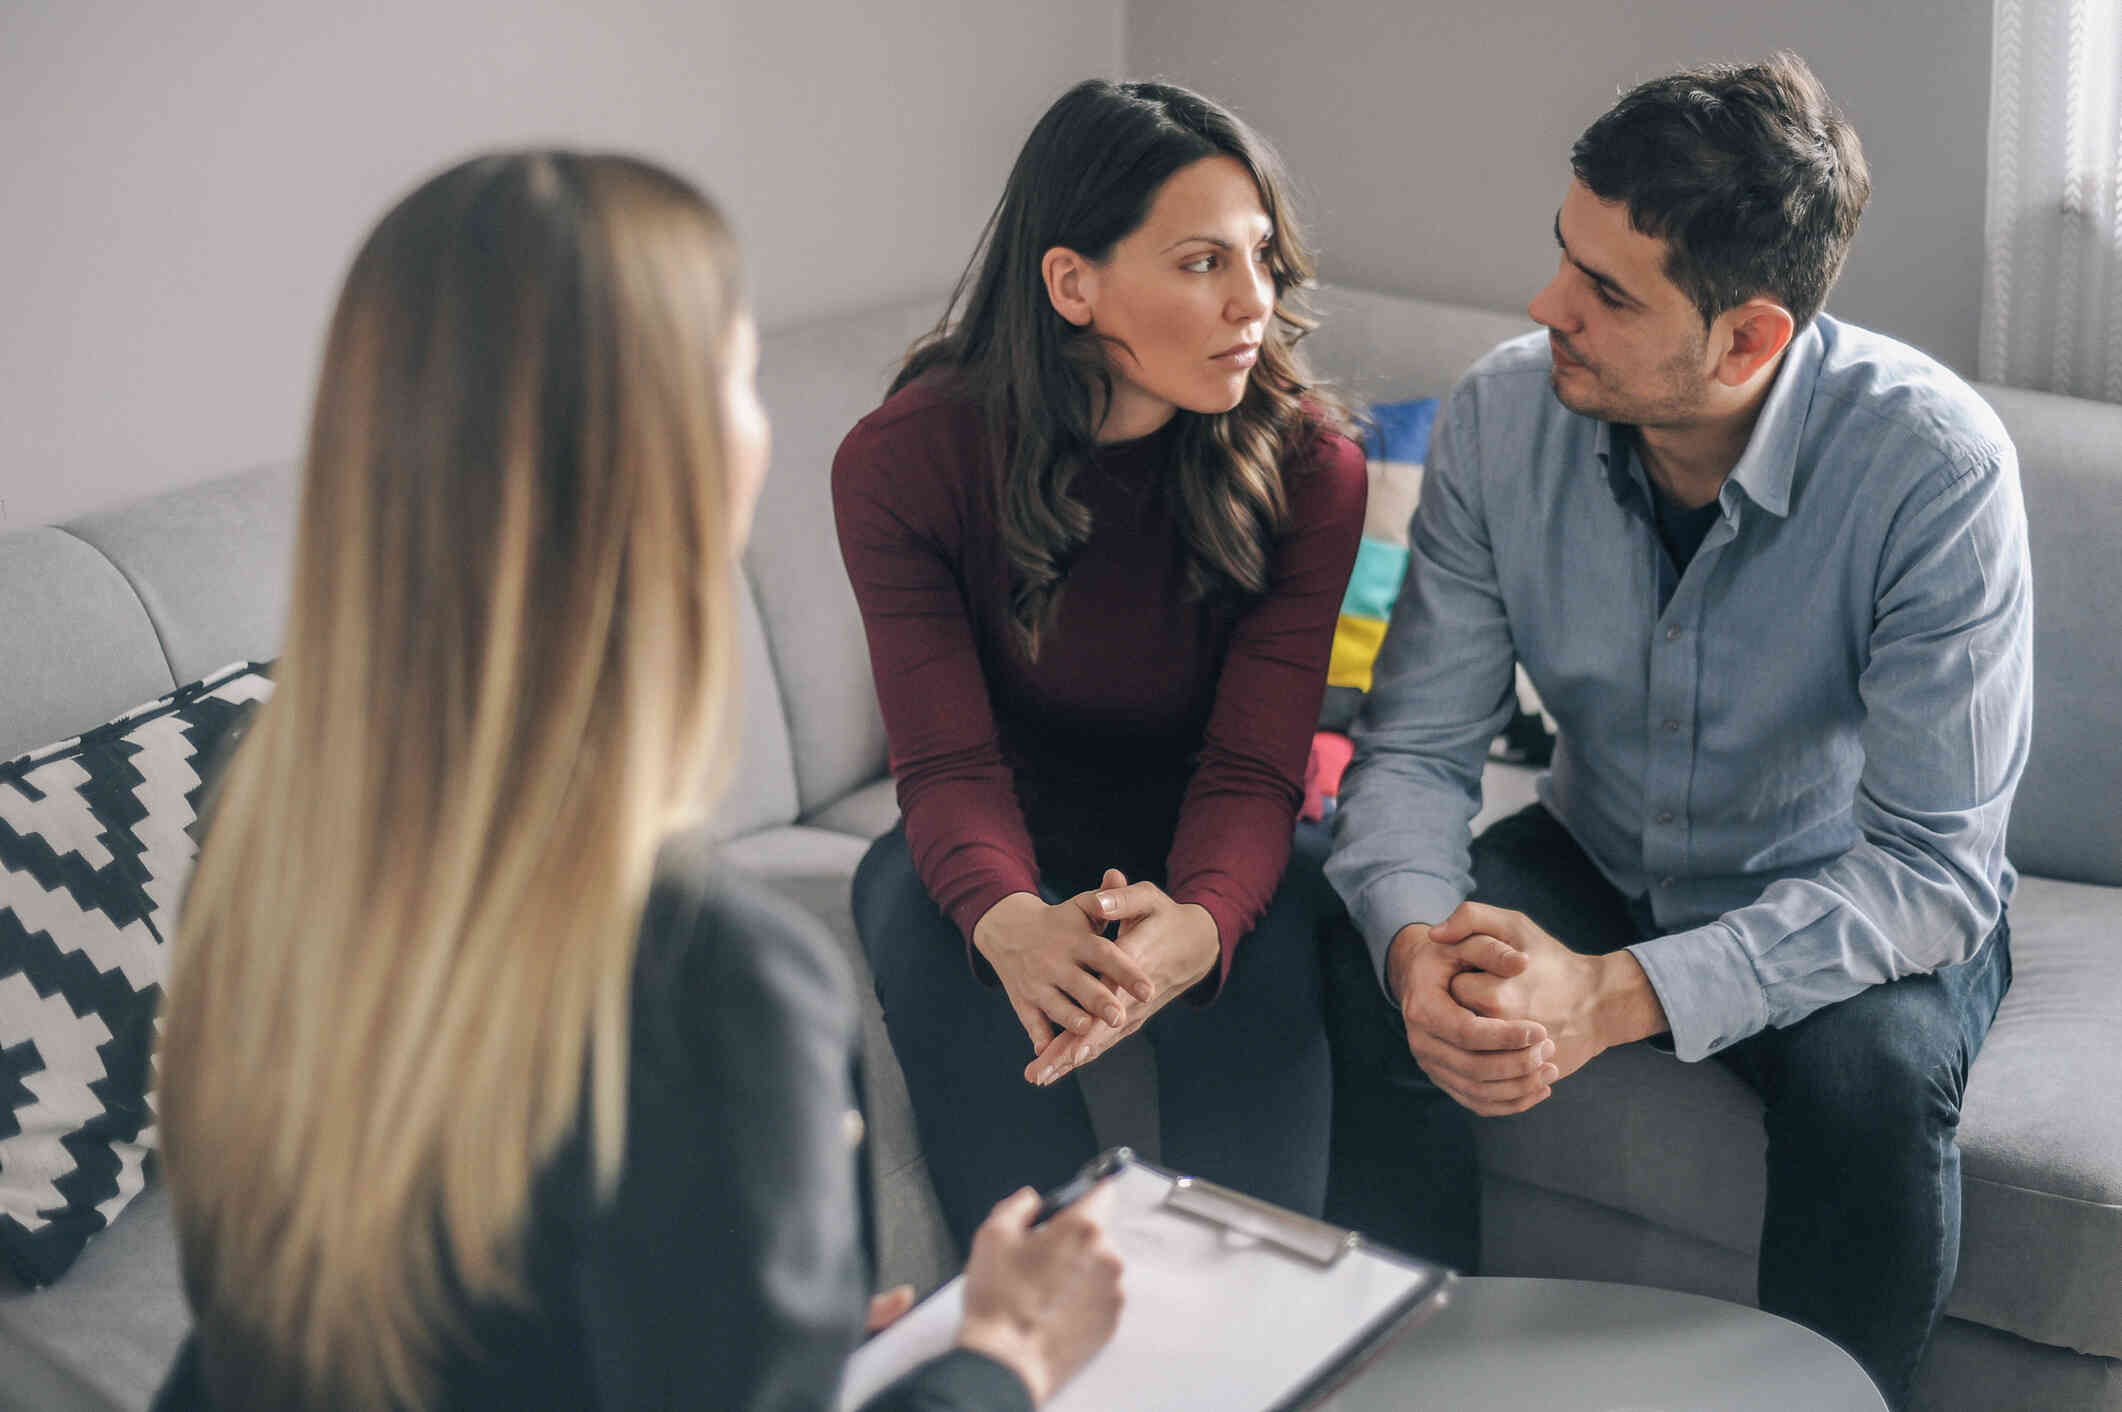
[[155, 834, 1031, 1412]]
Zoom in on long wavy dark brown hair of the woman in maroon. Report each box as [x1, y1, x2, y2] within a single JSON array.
[[891, 79, 1347, 658]]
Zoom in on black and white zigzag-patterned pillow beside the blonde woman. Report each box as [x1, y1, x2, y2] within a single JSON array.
[[0, 662, 272, 1287]]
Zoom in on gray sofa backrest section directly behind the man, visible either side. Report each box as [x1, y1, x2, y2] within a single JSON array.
[[1305, 287, 2122, 885]]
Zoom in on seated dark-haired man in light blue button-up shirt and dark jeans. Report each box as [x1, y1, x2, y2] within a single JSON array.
[[1328, 55, 2031, 1406]]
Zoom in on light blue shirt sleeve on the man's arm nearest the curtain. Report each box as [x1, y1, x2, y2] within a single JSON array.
[[1632, 444, 2033, 1060]]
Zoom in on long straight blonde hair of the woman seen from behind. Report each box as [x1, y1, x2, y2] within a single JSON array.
[[159, 153, 738, 1408]]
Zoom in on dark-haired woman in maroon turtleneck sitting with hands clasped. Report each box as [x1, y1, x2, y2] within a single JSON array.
[[834, 81, 1364, 1240]]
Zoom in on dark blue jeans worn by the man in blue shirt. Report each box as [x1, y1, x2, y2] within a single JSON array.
[[1326, 805, 2012, 1408]]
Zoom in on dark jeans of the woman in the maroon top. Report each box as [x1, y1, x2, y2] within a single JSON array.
[[855, 828, 1333, 1249]]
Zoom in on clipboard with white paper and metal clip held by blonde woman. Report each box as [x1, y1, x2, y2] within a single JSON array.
[[836, 1147, 1454, 1412]]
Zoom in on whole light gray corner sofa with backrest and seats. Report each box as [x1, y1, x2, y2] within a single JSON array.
[[0, 291, 2122, 1412]]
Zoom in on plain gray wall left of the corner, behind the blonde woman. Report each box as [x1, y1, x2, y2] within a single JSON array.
[[0, 0, 1123, 531]]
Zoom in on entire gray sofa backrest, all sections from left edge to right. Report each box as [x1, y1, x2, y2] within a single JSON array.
[[12, 287, 2122, 883]]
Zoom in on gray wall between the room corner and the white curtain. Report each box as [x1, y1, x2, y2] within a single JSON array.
[[1127, 0, 1990, 374]]
